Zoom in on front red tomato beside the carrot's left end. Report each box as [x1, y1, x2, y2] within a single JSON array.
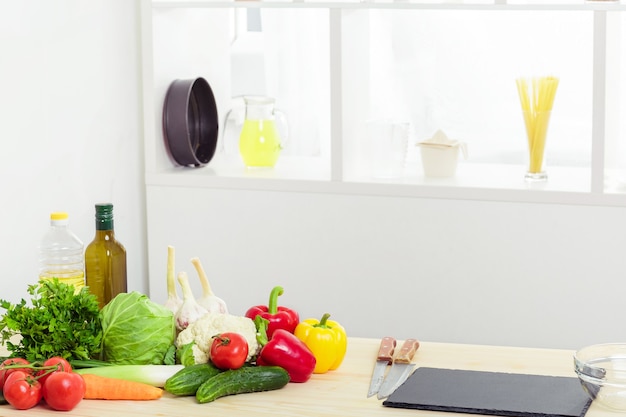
[[43, 372, 85, 411]]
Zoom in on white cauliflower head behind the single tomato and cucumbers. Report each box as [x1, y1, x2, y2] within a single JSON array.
[[176, 313, 260, 363]]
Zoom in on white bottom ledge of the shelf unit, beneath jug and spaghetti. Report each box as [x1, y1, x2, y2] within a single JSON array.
[[146, 154, 626, 206]]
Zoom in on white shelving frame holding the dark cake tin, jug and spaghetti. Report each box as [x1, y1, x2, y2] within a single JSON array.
[[141, 0, 626, 206]]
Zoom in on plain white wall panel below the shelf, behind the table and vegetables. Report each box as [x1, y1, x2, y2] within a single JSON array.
[[147, 186, 626, 349]]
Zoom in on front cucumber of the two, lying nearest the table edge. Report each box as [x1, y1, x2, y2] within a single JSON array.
[[196, 366, 289, 404]]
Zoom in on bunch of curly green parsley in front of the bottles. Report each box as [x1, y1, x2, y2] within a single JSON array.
[[0, 279, 102, 362]]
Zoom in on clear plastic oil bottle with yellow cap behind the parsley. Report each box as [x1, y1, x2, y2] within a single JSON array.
[[39, 212, 85, 289]]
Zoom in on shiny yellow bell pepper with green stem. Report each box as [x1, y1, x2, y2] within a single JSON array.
[[294, 313, 348, 374]]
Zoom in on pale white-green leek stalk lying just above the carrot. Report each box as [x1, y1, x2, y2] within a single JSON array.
[[74, 365, 184, 388]]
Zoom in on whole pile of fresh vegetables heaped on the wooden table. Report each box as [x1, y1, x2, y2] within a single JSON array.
[[0, 246, 347, 410]]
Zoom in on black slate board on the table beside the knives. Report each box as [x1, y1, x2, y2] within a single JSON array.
[[383, 368, 591, 417]]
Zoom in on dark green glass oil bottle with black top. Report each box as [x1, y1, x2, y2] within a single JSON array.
[[85, 204, 127, 308]]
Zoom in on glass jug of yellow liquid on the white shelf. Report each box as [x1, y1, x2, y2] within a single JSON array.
[[239, 96, 286, 168]]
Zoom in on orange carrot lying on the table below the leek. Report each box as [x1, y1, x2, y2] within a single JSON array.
[[82, 374, 163, 400]]
